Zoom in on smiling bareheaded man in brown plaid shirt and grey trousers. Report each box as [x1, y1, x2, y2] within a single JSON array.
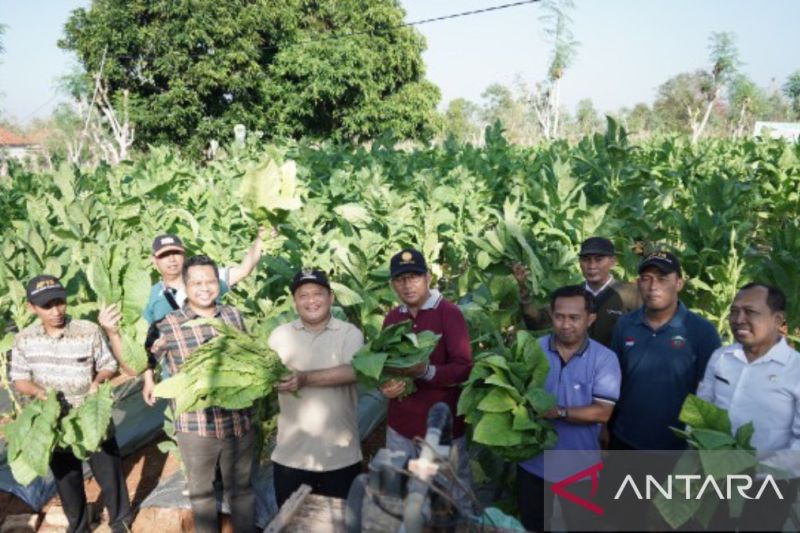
[[144, 255, 255, 533]]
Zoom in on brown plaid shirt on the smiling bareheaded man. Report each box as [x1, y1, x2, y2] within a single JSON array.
[[156, 305, 251, 439]]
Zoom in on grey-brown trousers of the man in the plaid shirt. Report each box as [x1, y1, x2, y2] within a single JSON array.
[[177, 429, 256, 533]]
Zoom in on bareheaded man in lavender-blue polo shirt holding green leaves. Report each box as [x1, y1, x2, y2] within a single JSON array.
[[517, 285, 620, 531]]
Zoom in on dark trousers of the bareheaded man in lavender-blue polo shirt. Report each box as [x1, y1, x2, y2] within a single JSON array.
[[517, 465, 599, 531]]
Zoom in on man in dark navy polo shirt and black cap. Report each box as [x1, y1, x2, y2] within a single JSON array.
[[611, 252, 721, 450]]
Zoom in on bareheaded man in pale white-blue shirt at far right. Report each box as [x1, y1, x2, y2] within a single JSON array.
[[697, 283, 800, 531]]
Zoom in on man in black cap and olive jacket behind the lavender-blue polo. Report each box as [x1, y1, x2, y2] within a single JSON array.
[[512, 237, 641, 347]]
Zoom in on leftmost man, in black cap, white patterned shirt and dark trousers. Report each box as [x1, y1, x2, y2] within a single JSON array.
[[9, 275, 132, 532]]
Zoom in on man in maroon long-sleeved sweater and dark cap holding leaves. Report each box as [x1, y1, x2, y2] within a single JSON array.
[[381, 249, 472, 510]]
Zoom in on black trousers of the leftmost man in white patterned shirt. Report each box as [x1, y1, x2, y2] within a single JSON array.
[[50, 437, 132, 533]]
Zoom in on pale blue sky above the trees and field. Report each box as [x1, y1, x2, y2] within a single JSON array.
[[0, 0, 800, 124]]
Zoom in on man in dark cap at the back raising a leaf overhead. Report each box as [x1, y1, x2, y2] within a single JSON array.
[[142, 227, 274, 324]]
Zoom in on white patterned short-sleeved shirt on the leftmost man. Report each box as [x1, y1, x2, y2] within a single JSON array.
[[8, 318, 117, 407]]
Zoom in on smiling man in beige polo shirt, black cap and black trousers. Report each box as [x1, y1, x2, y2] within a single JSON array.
[[268, 270, 364, 506]]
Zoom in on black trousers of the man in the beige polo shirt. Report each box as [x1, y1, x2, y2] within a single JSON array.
[[272, 462, 361, 507]]
